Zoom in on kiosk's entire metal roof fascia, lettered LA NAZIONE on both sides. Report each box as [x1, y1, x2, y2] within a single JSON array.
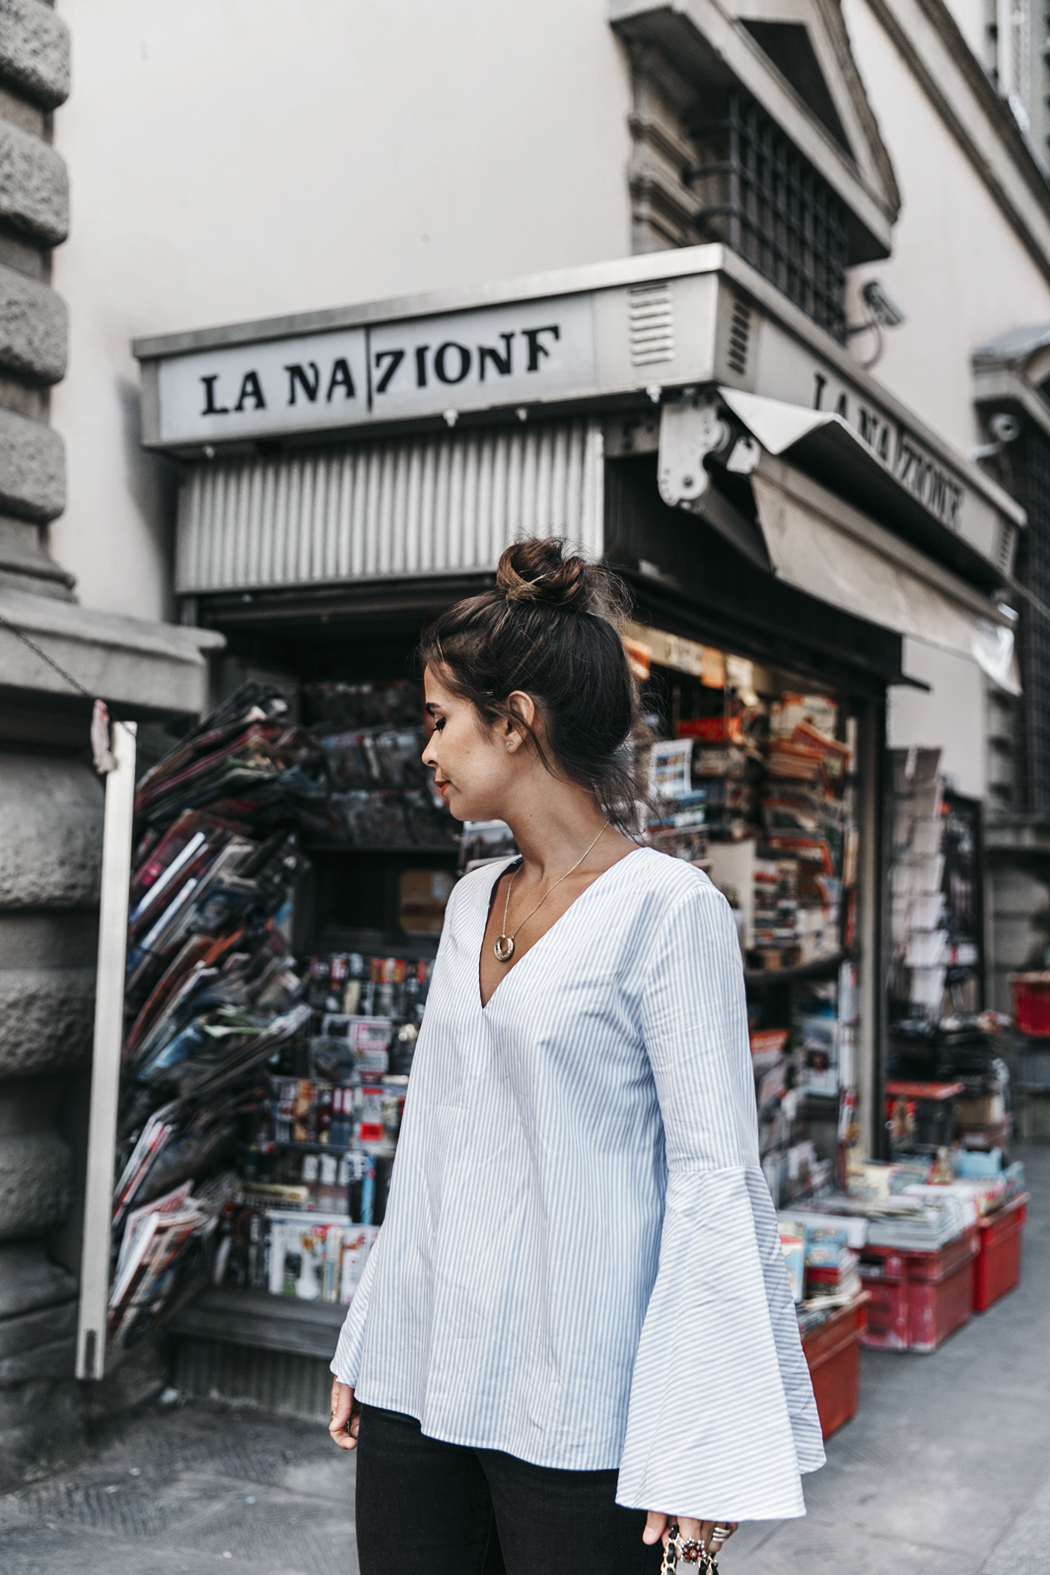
[[134, 255, 1023, 582]]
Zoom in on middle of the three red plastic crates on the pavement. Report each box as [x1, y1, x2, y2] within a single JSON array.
[[861, 1230, 978, 1351]]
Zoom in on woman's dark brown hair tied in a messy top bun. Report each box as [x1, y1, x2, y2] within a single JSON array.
[[420, 537, 638, 835]]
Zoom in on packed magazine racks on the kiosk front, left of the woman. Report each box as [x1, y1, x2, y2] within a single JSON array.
[[109, 682, 458, 1347]]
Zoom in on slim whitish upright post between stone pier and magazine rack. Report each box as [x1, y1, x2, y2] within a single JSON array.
[[77, 721, 137, 1378]]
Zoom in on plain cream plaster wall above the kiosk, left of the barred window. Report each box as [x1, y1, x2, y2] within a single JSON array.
[[52, 0, 630, 617]]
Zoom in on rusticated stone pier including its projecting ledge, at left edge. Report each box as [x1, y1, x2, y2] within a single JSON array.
[[0, 0, 215, 1482]]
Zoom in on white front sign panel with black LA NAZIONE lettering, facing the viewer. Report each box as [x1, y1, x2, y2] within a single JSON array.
[[157, 295, 595, 446]]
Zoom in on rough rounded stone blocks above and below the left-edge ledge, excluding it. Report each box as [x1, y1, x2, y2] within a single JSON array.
[[0, 0, 85, 1482]]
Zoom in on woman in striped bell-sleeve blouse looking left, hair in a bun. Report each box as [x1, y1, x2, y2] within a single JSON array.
[[331, 540, 823, 1575]]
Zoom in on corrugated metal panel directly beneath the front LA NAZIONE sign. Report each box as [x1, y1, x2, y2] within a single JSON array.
[[175, 419, 603, 595]]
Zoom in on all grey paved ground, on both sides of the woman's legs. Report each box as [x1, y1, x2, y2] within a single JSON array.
[[0, 1147, 1050, 1575]]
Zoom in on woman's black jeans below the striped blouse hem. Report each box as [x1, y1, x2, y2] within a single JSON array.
[[357, 1405, 663, 1575]]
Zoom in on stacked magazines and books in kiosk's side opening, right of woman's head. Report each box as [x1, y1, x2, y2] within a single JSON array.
[[647, 641, 860, 1202]]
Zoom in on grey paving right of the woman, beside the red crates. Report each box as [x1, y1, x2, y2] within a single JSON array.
[[721, 1143, 1050, 1575]]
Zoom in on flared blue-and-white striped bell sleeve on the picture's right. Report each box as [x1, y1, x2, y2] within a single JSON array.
[[617, 877, 823, 1520]]
